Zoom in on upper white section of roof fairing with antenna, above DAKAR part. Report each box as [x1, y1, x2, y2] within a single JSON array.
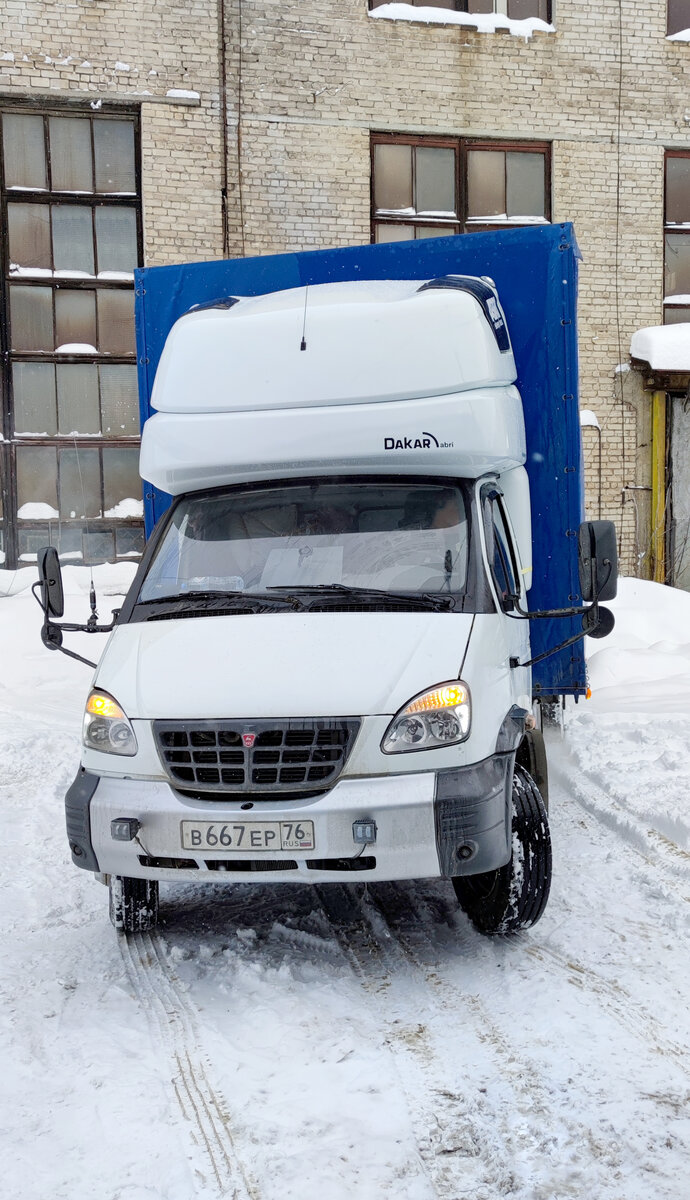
[[151, 276, 515, 413]]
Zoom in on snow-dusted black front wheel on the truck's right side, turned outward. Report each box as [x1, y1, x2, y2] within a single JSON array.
[[452, 767, 551, 934]]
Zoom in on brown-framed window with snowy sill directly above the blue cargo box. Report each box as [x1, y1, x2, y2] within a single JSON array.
[[372, 133, 551, 241]]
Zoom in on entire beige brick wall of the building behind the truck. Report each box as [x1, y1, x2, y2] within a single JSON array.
[[0, 0, 690, 570]]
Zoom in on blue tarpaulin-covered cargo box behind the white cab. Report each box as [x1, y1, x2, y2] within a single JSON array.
[[134, 224, 587, 696]]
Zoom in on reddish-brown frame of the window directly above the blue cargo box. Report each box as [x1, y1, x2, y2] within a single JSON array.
[[370, 130, 552, 242]]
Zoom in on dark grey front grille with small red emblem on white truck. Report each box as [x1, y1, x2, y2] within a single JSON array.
[[154, 718, 360, 799]]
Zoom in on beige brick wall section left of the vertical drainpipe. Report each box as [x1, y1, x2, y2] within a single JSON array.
[[0, 0, 223, 265]]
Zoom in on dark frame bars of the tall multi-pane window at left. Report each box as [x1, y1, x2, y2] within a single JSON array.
[[0, 97, 144, 566]]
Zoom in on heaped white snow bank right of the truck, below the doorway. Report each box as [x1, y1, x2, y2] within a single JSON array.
[[586, 578, 690, 713]]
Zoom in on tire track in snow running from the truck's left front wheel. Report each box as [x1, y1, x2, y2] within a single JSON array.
[[119, 934, 259, 1200]]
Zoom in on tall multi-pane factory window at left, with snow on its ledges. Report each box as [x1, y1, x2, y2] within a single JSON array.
[[0, 107, 144, 565]]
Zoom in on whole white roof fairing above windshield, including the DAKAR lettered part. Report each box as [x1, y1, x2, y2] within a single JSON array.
[[140, 276, 526, 496]]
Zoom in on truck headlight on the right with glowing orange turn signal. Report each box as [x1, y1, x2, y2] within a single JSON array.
[[380, 680, 470, 754]]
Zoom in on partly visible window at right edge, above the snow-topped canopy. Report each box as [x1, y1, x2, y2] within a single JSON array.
[[664, 150, 690, 325]]
